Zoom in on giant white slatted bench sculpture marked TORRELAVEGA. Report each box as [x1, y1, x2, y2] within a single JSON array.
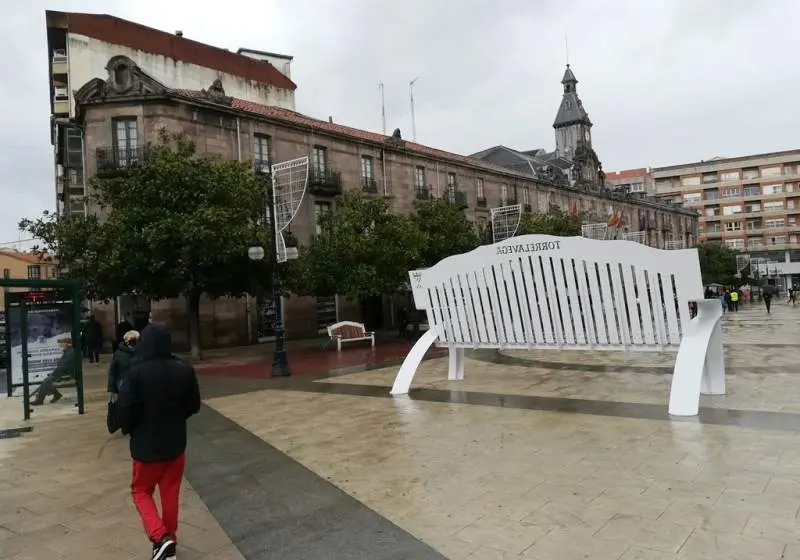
[[391, 235, 725, 416]]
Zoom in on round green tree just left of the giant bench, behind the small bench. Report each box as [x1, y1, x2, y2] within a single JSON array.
[[287, 192, 426, 300]]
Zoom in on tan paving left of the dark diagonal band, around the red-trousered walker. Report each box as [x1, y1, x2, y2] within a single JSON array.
[[0, 406, 242, 560]]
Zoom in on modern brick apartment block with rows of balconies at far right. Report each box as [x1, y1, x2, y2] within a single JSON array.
[[652, 150, 800, 285]]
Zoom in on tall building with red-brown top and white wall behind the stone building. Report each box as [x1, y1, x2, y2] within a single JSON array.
[[45, 10, 297, 219]]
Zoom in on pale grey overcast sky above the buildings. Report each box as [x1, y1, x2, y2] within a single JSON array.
[[0, 0, 800, 242]]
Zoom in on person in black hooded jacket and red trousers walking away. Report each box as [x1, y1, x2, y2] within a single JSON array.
[[117, 323, 200, 560]]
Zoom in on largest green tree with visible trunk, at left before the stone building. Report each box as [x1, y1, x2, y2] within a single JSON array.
[[21, 130, 272, 357]]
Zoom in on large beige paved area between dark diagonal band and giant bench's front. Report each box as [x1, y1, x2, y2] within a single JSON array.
[[209, 390, 800, 560]]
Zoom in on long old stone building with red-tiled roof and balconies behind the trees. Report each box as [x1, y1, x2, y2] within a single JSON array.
[[70, 57, 697, 346]]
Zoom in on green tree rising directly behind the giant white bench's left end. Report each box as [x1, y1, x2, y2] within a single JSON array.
[[412, 199, 480, 268]]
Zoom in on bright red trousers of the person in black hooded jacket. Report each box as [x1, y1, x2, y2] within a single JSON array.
[[131, 453, 186, 542]]
